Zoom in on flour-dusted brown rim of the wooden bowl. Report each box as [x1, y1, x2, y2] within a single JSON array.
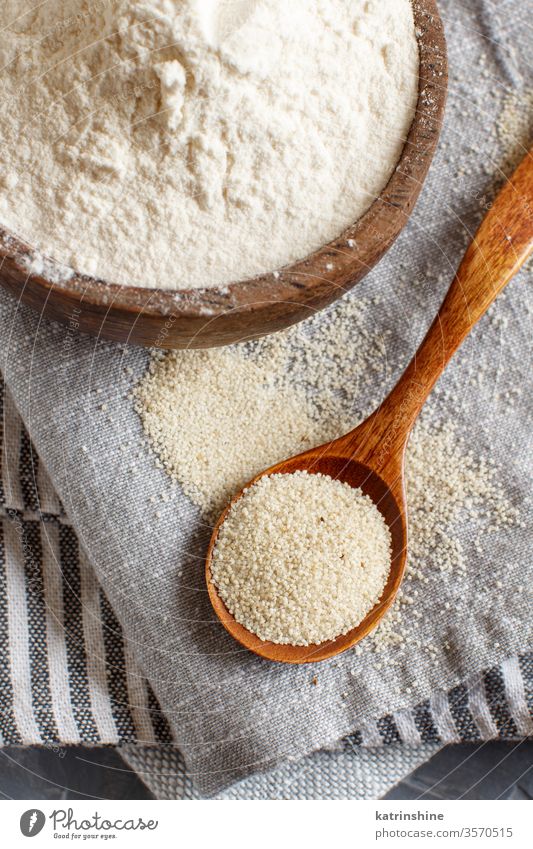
[[0, 0, 448, 332]]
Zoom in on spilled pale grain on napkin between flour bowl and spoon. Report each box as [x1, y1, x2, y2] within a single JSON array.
[[134, 300, 383, 521]]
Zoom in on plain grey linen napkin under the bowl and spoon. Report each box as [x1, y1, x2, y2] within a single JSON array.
[[0, 2, 532, 793]]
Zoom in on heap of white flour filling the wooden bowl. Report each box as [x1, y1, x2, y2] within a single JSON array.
[[0, 0, 418, 289]]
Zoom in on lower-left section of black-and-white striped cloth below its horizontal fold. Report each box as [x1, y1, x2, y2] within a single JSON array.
[[0, 513, 174, 748]]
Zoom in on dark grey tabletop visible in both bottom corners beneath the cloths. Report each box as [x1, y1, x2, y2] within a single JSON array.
[[0, 740, 533, 800]]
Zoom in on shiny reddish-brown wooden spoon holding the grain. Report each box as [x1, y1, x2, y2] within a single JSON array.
[[206, 151, 533, 663]]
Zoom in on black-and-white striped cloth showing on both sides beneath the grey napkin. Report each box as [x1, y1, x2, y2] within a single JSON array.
[[0, 382, 533, 747]]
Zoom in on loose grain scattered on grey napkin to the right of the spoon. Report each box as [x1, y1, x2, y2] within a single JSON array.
[[366, 421, 524, 656]]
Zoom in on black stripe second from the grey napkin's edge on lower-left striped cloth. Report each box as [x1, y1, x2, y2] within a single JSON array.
[[100, 590, 136, 743]]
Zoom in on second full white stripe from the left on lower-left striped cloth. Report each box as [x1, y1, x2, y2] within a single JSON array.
[[41, 523, 80, 744]]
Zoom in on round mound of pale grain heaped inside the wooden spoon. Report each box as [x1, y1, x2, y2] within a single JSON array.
[[212, 472, 391, 646]]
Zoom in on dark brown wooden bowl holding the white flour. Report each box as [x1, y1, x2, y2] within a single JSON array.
[[0, 0, 447, 349]]
